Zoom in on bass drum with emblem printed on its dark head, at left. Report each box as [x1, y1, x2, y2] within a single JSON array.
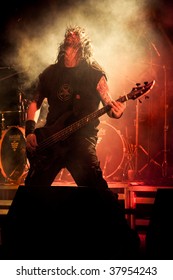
[[0, 126, 27, 183]]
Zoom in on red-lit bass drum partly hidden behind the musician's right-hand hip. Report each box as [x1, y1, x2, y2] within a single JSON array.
[[96, 121, 125, 181]]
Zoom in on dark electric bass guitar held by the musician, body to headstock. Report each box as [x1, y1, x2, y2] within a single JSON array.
[[28, 80, 155, 161]]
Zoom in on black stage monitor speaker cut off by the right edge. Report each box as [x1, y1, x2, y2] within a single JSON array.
[[146, 188, 173, 260]]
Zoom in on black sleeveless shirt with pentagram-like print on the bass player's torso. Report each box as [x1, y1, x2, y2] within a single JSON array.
[[32, 61, 105, 135]]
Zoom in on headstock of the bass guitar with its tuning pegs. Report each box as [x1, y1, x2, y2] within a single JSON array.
[[127, 80, 155, 100]]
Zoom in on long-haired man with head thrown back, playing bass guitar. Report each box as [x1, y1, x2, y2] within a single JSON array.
[[25, 26, 125, 189]]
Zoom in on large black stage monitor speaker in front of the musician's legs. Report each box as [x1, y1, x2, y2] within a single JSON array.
[[3, 186, 139, 259]]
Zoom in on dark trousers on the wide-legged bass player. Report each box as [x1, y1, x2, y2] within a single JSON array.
[[25, 137, 108, 189]]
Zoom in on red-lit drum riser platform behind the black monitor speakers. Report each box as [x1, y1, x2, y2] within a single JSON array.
[[0, 179, 173, 258]]
